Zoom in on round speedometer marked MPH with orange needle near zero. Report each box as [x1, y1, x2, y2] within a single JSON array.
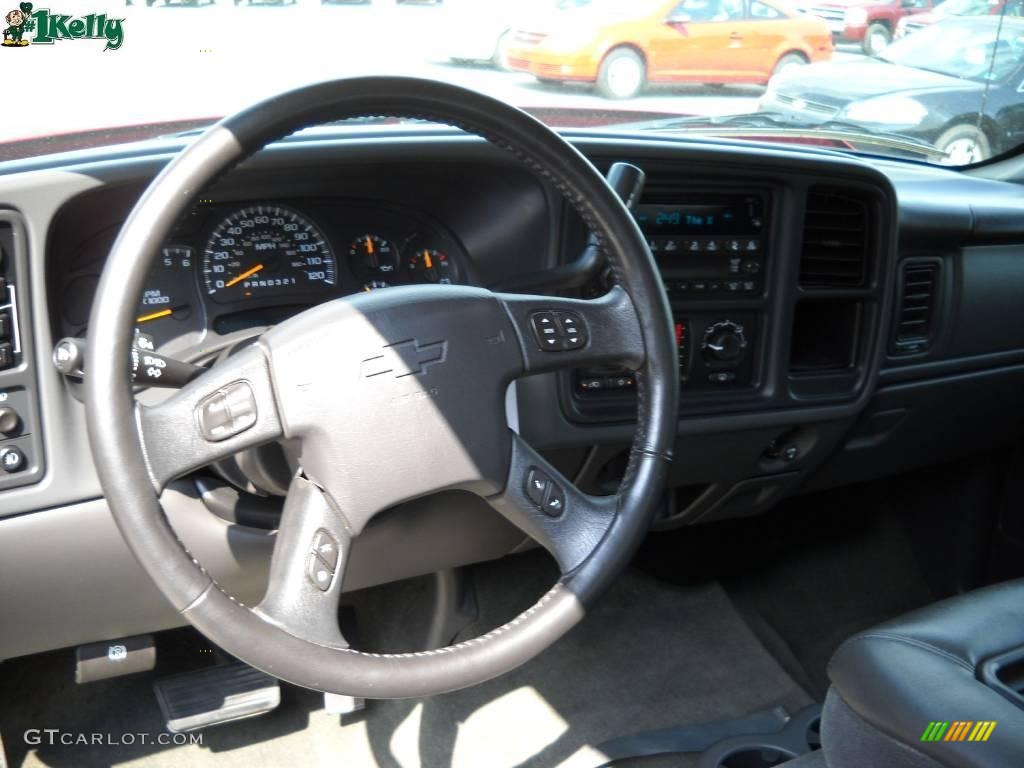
[[203, 205, 335, 302]]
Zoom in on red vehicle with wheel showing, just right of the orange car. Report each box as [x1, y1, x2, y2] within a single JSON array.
[[802, 0, 938, 56]]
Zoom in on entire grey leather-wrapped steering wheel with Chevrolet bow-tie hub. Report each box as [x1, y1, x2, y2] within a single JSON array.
[[86, 78, 678, 698]]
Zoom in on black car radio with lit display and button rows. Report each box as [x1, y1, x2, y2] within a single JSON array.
[[634, 195, 765, 298]]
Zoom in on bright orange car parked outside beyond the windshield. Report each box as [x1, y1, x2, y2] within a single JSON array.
[[508, 0, 833, 98]]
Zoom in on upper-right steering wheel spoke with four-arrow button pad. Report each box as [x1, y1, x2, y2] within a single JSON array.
[[496, 286, 644, 375]]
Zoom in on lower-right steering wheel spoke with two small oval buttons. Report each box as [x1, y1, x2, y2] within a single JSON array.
[[487, 435, 617, 573]]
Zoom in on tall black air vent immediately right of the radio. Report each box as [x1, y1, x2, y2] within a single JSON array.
[[800, 188, 870, 288]]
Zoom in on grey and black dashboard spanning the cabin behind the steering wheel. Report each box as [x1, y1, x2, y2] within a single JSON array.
[[0, 127, 1024, 658]]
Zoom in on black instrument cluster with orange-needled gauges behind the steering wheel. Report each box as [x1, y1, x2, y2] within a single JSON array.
[[74, 200, 472, 346]]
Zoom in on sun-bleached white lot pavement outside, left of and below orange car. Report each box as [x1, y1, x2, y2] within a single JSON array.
[[0, 0, 857, 141]]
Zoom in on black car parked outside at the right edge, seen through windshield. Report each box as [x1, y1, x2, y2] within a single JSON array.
[[760, 16, 1024, 165]]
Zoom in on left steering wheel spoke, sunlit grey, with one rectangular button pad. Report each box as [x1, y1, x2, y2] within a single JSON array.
[[135, 344, 282, 492]]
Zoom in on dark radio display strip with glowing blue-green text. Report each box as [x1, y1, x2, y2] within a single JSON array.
[[635, 196, 764, 238]]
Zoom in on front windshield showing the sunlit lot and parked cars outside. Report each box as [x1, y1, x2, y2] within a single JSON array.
[[0, 0, 1024, 165]]
